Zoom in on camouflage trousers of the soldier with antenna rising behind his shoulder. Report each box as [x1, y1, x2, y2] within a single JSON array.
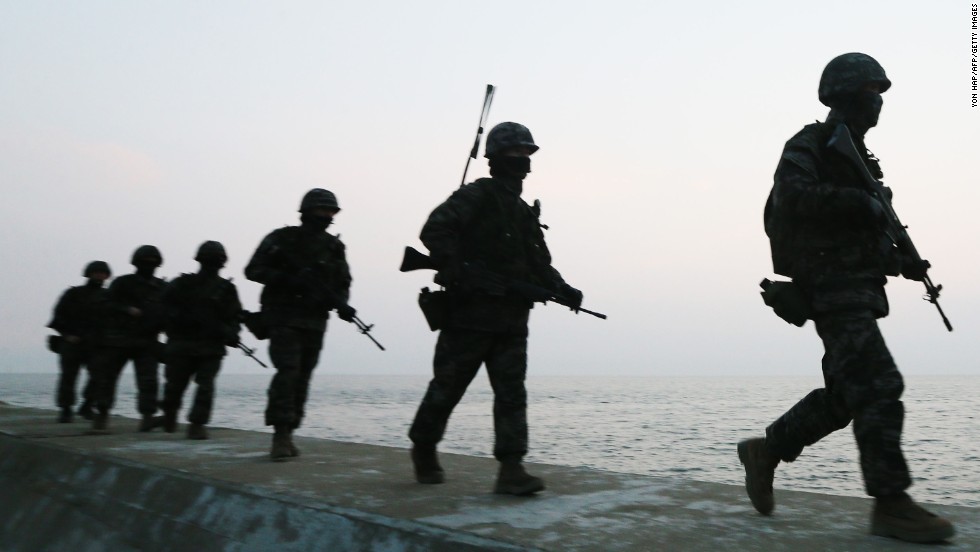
[[408, 329, 527, 461]]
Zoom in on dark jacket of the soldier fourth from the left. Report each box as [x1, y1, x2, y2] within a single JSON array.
[[245, 226, 351, 331]]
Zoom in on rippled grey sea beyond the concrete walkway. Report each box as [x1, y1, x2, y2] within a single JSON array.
[[0, 368, 980, 507]]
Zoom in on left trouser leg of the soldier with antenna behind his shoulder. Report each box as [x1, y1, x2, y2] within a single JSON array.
[[408, 329, 493, 446]]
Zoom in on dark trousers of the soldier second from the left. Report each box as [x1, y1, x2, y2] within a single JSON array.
[[92, 343, 160, 416]]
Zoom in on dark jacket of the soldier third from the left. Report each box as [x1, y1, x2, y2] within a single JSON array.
[[162, 274, 242, 356]]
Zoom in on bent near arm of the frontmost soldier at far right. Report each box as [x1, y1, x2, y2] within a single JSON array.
[[772, 147, 871, 220]]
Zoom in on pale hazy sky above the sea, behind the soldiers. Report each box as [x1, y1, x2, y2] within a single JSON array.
[[0, 0, 980, 381]]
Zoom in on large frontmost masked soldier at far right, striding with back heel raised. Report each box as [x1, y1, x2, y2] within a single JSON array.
[[738, 53, 954, 542]]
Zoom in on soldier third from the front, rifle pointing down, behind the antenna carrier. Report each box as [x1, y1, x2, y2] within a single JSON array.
[[245, 188, 356, 461]]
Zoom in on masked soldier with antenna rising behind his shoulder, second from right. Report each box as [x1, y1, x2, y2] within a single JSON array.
[[409, 122, 582, 495]]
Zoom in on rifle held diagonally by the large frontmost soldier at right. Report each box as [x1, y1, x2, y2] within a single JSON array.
[[827, 123, 953, 331]]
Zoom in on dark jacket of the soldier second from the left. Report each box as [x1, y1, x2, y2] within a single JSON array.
[[100, 274, 167, 347]]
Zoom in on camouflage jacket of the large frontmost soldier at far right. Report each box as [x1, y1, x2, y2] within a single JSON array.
[[764, 120, 898, 316]]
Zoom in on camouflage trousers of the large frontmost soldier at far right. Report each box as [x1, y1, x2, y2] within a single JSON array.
[[766, 311, 911, 496]]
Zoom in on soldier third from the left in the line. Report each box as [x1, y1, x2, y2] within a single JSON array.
[[160, 241, 242, 439]]
